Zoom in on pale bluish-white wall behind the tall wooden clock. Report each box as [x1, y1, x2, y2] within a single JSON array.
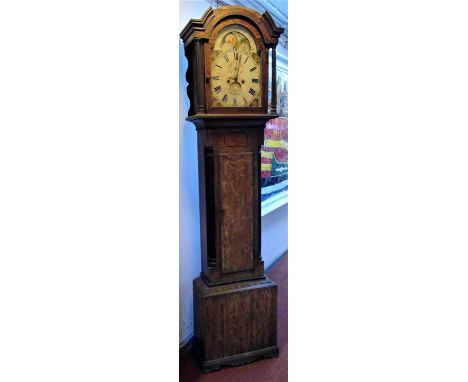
[[179, 0, 288, 344]]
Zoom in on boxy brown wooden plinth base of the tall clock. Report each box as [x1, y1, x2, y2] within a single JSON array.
[[193, 277, 279, 372]]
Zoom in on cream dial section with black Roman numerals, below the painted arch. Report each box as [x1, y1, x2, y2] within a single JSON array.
[[211, 50, 261, 107]]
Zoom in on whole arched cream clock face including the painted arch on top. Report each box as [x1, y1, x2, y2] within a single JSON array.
[[211, 25, 262, 108]]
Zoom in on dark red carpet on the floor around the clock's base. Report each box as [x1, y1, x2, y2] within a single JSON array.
[[179, 253, 288, 382]]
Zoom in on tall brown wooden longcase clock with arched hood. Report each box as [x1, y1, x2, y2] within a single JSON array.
[[180, 6, 283, 372]]
